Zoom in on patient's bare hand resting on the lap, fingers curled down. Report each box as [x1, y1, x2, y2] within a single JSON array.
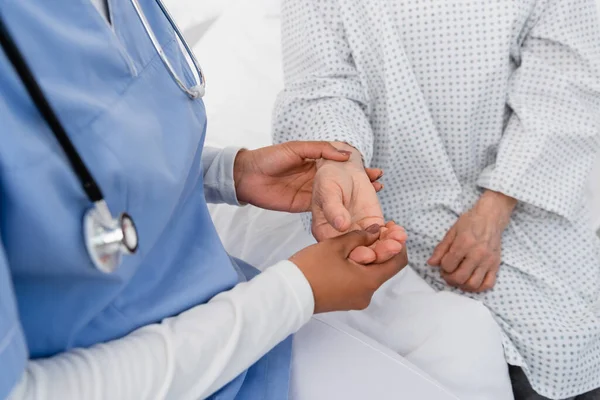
[[427, 190, 517, 292]]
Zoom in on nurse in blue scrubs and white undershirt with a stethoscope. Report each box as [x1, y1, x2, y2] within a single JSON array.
[[0, 0, 407, 400]]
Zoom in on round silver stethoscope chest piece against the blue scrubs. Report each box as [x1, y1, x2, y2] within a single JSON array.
[[83, 201, 138, 274]]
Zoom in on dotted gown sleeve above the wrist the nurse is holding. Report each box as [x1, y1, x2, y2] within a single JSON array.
[[273, 0, 373, 165]]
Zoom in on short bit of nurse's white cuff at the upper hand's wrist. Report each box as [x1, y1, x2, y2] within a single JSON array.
[[202, 147, 240, 206]]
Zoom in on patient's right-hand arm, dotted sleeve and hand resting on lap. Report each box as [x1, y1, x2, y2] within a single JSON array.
[[428, 0, 600, 292]]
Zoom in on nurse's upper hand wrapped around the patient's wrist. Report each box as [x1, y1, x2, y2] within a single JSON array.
[[234, 142, 383, 213]]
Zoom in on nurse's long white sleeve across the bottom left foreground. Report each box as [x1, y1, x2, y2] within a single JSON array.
[[10, 261, 314, 400]]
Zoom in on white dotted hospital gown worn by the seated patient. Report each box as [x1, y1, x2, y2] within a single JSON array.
[[274, 0, 600, 399]]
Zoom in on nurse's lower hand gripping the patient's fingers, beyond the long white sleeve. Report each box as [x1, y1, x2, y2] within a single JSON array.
[[290, 225, 408, 313]]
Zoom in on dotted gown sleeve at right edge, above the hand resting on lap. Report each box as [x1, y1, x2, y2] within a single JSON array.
[[478, 0, 600, 220]]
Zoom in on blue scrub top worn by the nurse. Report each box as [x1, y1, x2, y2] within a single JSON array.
[[0, 0, 290, 399]]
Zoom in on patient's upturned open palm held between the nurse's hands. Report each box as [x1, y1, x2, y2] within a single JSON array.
[[311, 143, 406, 264]]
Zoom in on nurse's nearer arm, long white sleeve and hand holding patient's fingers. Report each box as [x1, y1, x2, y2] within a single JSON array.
[[5, 225, 408, 400]]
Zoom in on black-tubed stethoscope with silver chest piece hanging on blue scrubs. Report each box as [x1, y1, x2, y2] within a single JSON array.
[[0, 0, 205, 273]]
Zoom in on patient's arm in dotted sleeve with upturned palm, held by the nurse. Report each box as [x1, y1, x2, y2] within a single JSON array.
[[273, 0, 390, 245]]
